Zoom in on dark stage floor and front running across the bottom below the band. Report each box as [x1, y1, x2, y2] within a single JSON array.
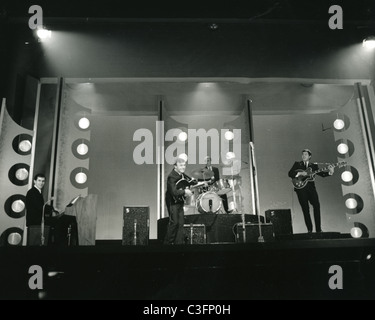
[[0, 234, 375, 300]]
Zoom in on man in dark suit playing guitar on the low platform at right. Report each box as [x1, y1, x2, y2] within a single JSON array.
[[288, 149, 334, 233]]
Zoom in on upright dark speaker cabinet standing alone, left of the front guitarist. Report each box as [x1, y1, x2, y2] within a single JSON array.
[[122, 206, 150, 246]]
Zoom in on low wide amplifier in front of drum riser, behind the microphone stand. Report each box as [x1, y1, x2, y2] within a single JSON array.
[[236, 223, 275, 243]]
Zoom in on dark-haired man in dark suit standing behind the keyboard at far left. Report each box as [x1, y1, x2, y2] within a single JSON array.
[[26, 174, 46, 227]]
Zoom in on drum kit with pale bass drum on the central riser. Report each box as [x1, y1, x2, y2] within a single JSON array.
[[187, 168, 240, 214]]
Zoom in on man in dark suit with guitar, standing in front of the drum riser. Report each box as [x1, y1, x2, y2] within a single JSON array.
[[164, 158, 193, 244]]
